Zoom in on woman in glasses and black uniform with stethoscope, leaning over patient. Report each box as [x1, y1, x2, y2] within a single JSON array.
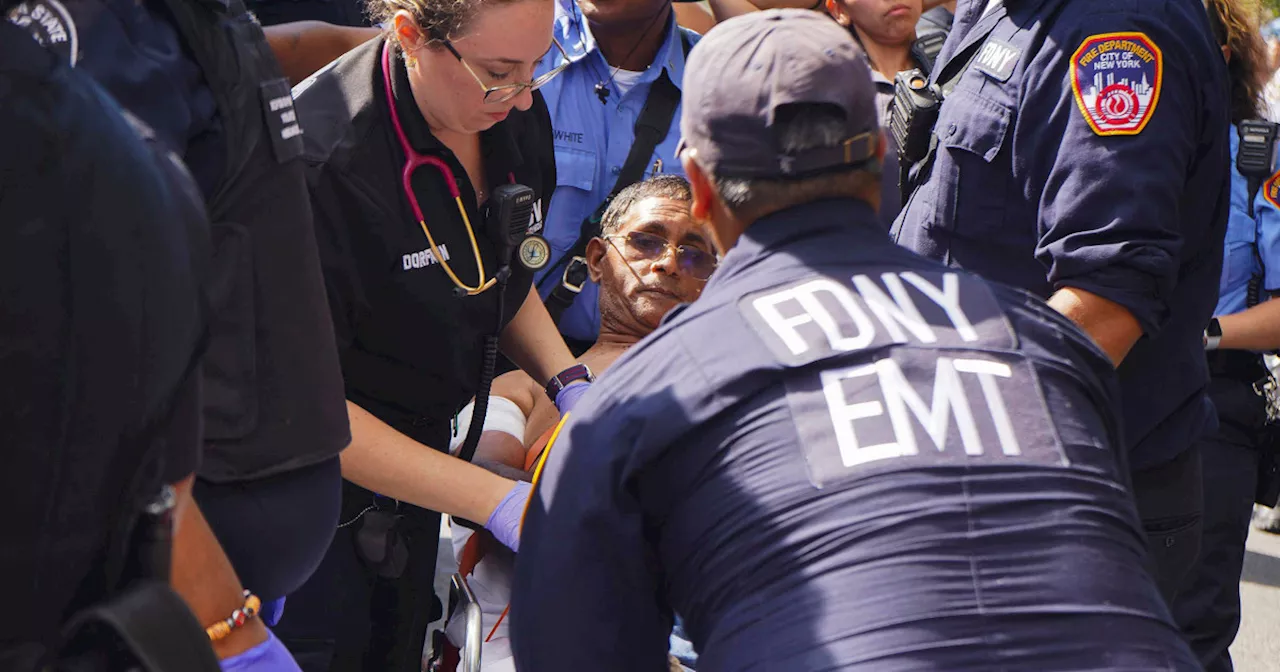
[[278, 0, 590, 672]]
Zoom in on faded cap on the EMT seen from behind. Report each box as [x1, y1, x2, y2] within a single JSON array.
[[680, 9, 879, 178]]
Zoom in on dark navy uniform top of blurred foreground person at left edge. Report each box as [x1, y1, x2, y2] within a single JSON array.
[[0, 20, 209, 671]]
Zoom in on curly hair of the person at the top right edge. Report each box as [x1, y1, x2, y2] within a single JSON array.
[[1204, 0, 1270, 123]]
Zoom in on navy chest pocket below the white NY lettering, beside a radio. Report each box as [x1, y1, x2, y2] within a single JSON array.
[[932, 90, 1008, 237]]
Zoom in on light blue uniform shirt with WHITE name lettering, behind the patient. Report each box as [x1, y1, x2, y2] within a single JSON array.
[[535, 0, 698, 340]]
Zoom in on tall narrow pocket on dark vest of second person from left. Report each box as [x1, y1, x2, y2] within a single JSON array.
[[204, 221, 257, 440]]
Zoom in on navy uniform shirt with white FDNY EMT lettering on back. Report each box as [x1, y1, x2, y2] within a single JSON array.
[[512, 201, 1196, 672]]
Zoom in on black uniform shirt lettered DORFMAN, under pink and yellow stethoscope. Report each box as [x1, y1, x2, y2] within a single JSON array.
[[294, 40, 556, 448]]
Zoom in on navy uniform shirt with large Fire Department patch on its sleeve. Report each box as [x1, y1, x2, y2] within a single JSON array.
[[895, 0, 1229, 470]]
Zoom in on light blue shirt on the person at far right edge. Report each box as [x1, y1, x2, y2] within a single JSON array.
[[1213, 127, 1280, 315]]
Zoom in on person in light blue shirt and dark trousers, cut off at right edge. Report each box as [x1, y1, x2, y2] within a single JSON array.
[[1172, 0, 1280, 672]]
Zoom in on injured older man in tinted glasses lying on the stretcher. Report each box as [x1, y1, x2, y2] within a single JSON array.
[[448, 175, 717, 672]]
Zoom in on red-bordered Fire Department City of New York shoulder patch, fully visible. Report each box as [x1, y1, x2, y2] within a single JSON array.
[[1071, 32, 1165, 136]]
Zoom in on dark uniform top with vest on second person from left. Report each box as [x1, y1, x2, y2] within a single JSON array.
[[5, 0, 351, 483]]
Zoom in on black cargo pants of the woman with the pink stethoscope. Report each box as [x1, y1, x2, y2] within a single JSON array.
[[275, 481, 442, 672]]
